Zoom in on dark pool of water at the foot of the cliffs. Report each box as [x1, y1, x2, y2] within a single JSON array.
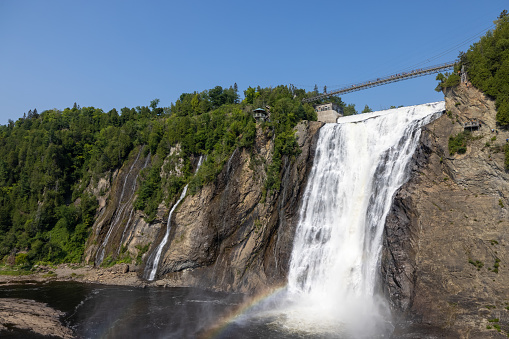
[[0, 282, 322, 339]]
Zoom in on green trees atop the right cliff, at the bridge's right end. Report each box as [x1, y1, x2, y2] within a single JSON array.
[[460, 13, 509, 125]]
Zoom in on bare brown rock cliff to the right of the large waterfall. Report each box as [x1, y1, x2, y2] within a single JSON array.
[[381, 84, 509, 338]]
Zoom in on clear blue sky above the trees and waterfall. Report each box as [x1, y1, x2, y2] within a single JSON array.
[[0, 0, 509, 124]]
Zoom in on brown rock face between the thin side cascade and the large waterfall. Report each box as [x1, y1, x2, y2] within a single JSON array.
[[152, 122, 322, 292]]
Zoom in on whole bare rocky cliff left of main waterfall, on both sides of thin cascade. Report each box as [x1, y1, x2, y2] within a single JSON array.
[[86, 121, 323, 292]]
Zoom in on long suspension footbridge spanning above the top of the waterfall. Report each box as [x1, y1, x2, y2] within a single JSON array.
[[302, 61, 457, 102]]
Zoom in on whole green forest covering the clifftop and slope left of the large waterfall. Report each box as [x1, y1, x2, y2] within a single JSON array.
[[0, 85, 346, 264]]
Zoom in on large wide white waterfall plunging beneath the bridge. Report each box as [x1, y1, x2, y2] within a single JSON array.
[[286, 102, 445, 337]]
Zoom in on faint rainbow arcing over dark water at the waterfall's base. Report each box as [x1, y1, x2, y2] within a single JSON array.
[[198, 284, 286, 339]]
